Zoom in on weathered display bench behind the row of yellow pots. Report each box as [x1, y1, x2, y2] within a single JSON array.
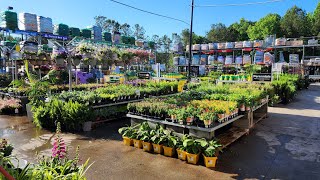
[[127, 101, 268, 148]]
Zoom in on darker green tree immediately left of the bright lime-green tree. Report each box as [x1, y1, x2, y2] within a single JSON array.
[[229, 18, 254, 41]]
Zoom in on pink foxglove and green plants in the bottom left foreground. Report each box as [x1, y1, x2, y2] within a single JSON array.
[[0, 123, 92, 180]]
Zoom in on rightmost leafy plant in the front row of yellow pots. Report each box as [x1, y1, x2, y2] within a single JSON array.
[[201, 140, 221, 168]]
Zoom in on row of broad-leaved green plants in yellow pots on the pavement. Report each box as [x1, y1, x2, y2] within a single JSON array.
[[119, 122, 221, 167]]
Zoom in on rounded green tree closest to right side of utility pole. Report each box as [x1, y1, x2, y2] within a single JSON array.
[[207, 23, 230, 42]]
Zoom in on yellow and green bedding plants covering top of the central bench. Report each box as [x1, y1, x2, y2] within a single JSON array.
[[128, 84, 269, 127]]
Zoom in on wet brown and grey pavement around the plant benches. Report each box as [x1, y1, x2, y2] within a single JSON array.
[[0, 84, 320, 180]]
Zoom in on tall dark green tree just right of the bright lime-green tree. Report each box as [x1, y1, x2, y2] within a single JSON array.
[[281, 6, 311, 37]]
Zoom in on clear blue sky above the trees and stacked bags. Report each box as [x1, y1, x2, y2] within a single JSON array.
[[0, 0, 319, 36]]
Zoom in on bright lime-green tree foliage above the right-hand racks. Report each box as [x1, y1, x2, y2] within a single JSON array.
[[247, 14, 282, 40]]
